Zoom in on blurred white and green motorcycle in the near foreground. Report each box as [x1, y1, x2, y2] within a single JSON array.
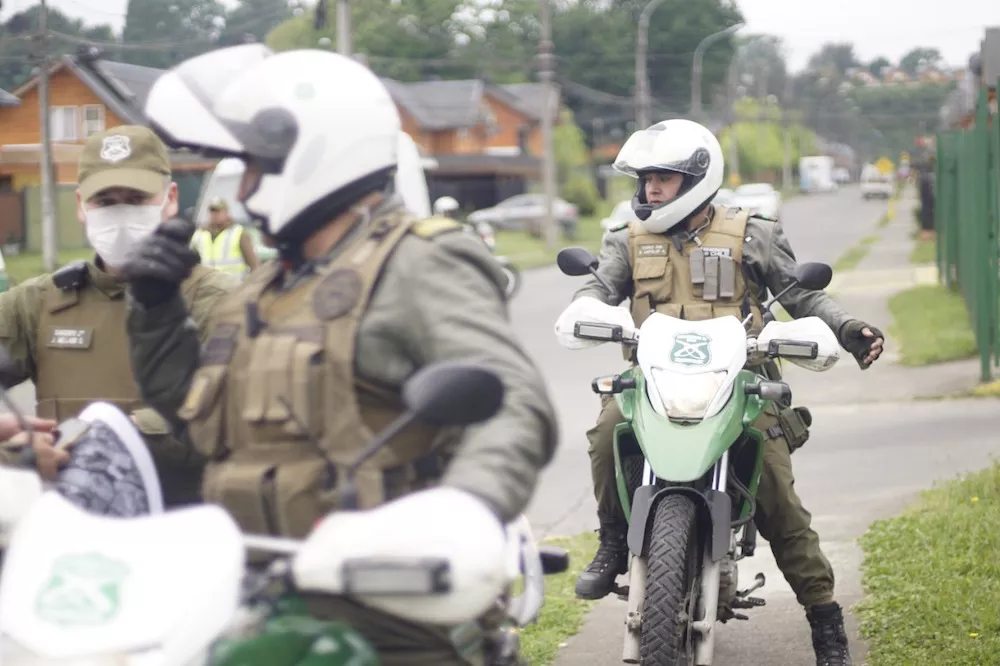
[[0, 364, 568, 666]]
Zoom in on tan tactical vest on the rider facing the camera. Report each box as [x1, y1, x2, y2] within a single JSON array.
[[629, 206, 763, 352]]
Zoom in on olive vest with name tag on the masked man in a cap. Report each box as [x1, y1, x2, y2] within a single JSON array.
[[35, 265, 211, 421]]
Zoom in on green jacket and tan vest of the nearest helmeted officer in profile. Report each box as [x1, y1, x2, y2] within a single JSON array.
[[129, 198, 557, 666]]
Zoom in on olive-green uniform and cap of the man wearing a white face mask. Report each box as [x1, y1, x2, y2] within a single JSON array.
[[0, 126, 238, 506]]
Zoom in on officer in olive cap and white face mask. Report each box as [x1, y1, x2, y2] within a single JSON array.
[[0, 125, 237, 506]]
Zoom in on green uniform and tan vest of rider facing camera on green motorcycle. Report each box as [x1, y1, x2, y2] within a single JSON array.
[[574, 206, 852, 607]]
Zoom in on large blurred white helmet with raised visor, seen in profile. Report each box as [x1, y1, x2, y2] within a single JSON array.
[[145, 44, 401, 256]]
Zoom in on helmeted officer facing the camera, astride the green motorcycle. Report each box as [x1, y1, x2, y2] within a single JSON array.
[[574, 120, 883, 666]]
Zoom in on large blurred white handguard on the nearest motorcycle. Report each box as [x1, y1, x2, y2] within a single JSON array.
[[292, 487, 512, 625]]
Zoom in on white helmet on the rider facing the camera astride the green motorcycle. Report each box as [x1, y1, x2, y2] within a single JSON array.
[[613, 119, 725, 234]]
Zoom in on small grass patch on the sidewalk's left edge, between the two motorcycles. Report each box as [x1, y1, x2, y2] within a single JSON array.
[[521, 532, 597, 666]]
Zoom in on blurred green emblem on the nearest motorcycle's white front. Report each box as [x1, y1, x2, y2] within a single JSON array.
[[35, 553, 129, 627]]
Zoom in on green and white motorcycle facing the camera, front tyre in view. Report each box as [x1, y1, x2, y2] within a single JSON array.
[[556, 248, 840, 666]]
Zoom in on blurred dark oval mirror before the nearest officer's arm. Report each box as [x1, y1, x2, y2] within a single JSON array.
[[403, 363, 504, 426]]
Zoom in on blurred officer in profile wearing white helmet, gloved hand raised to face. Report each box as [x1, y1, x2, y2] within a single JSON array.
[[126, 44, 557, 666]]
